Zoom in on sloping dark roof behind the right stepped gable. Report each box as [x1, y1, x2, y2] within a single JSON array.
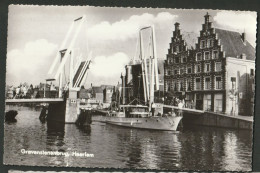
[[215, 28, 255, 60]]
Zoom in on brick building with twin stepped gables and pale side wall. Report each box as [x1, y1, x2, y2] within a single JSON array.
[[164, 13, 255, 115]]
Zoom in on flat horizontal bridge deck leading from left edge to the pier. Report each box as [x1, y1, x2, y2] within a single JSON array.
[[5, 98, 64, 104]]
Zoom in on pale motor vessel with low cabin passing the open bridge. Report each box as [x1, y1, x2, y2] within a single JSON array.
[[92, 105, 182, 131]]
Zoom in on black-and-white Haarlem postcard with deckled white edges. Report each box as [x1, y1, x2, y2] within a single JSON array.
[[3, 5, 257, 171]]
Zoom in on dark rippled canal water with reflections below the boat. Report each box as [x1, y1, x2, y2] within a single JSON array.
[[4, 106, 253, 171]]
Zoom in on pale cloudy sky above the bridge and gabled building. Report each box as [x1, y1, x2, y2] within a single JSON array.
[[6, 5, 257, 87]]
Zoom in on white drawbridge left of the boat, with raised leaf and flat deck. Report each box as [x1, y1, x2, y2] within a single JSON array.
[[6, 16, 92, 104]]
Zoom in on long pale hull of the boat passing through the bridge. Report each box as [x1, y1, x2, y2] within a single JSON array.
[[92, 116, 182, 131]]
